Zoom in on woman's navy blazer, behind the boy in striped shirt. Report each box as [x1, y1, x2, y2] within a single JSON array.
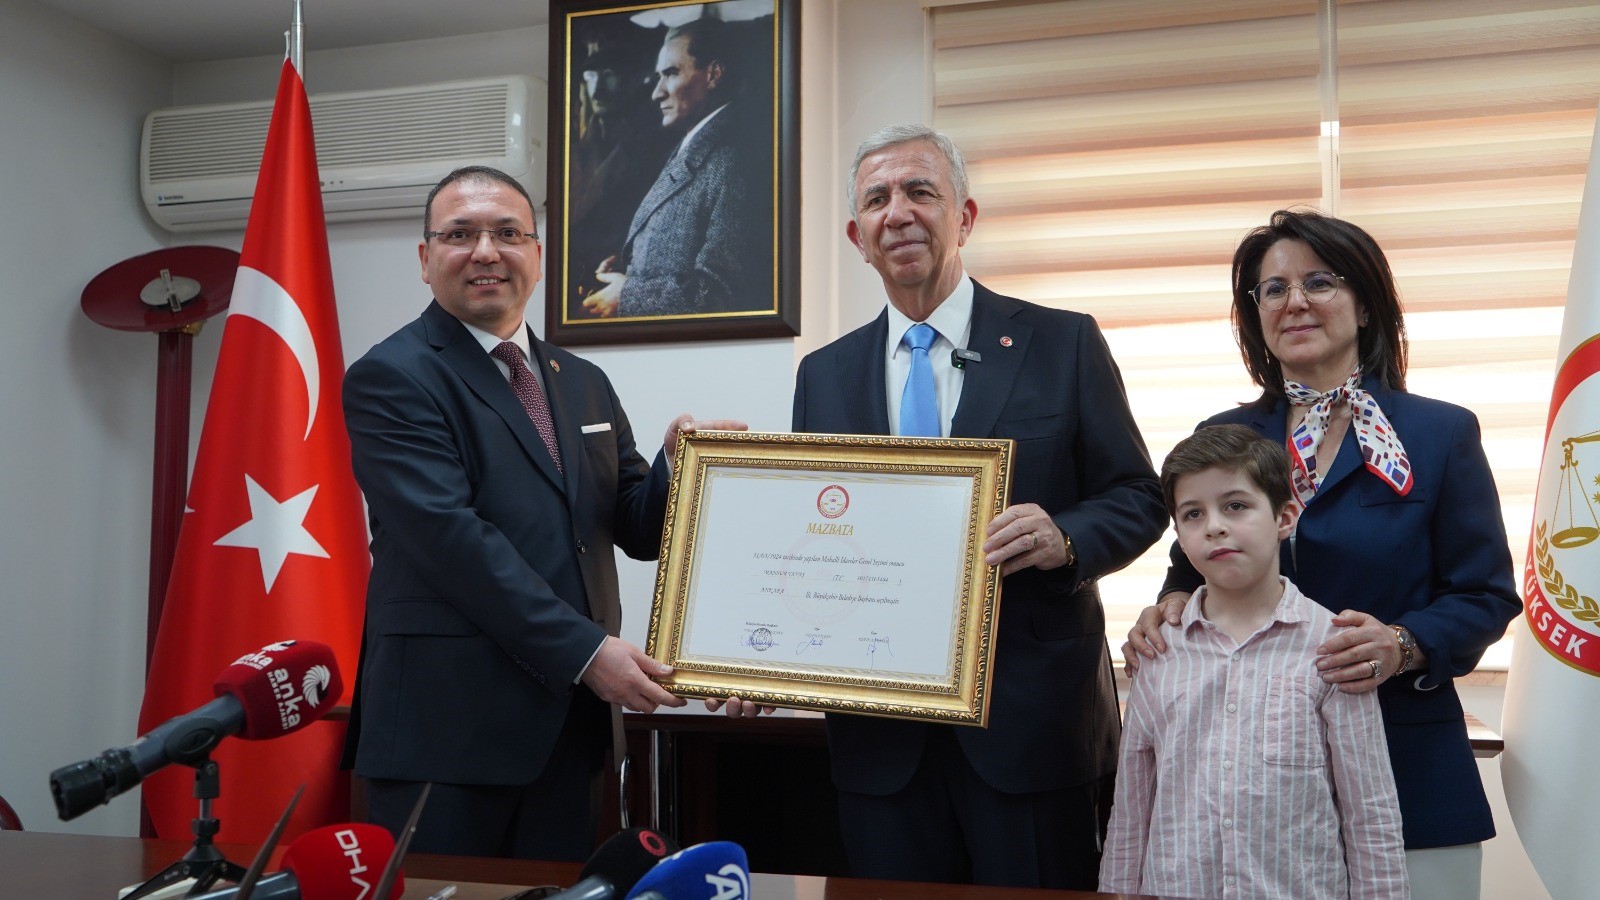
[[1162, 378, 1522, 850]]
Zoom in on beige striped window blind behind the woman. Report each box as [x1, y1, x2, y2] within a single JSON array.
[[931, 0, 1600, 647]]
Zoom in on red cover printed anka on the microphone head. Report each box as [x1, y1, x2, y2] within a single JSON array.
[[211, 641, 344, 740]]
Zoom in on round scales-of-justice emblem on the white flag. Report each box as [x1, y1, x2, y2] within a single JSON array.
[[1525, 431, 1600, 674]]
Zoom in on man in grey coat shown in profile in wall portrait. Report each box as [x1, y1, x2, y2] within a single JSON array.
[[584, 19, 774, 317]]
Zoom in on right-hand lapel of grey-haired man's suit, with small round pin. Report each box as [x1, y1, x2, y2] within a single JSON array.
[[950, 282, 1034, 437]]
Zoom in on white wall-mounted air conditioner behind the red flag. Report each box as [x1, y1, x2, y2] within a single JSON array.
[[139, 75, 549, 231]]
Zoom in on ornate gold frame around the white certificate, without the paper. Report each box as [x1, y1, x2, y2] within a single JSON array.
[[645, 431, 1013, 727]]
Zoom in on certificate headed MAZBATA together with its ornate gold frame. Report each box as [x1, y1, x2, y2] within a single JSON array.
[[646, 431, 1011, 727]]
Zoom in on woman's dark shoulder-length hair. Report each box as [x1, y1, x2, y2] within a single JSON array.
[[1234, 208, 1406, 399]]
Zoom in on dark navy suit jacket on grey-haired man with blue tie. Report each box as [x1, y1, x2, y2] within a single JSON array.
[[794, 282, 1166, 794]]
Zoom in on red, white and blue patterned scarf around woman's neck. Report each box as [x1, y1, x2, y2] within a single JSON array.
[[1283, 368, 1411, 506]]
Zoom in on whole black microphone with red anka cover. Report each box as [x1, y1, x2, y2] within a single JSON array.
[[50, 641, 344, 822]]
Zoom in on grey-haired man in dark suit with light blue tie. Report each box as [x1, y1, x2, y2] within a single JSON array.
[[728, 125, 1166, 890]]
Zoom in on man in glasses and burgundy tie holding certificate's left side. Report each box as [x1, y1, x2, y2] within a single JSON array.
[[344, 167, 738, 860]]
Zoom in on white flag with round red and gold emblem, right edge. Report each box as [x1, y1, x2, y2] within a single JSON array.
[[1501, 103, 1600, 900]]
